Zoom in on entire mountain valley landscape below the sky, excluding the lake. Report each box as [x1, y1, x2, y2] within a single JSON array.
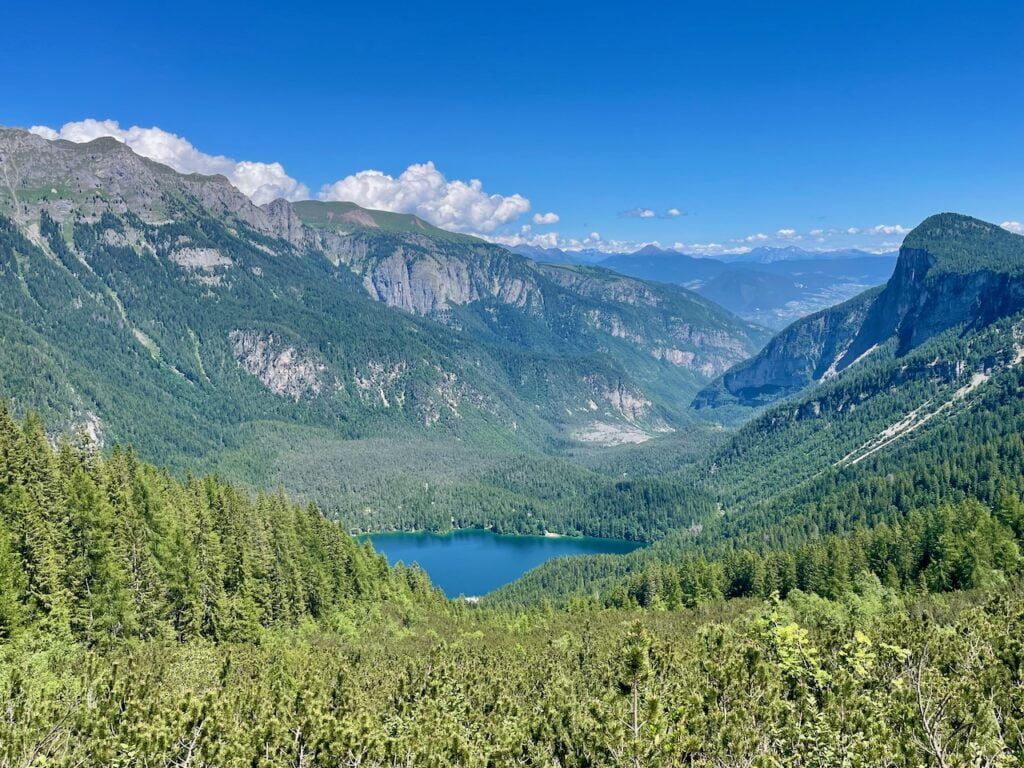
[[6, 130, 1024, 768]]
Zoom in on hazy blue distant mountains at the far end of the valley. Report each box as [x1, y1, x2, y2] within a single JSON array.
[[513, 240, 896, 329]]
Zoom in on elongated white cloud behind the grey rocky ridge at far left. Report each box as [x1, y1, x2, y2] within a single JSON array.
[[29, 119, 309, 205]]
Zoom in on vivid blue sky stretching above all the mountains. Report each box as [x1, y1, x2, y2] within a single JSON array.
[[0, 0, 1024, 252]]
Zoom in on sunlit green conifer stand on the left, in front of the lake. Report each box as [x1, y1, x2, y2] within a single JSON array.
[[0, 401, 442, 645]]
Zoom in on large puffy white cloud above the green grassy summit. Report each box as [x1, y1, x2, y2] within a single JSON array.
[[317, 162, 529, 233]]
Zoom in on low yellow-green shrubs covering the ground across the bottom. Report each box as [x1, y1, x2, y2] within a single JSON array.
[[6, 580, 1024, 768]]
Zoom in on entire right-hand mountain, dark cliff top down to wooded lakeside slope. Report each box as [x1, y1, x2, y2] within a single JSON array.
[[490, 213, 1024, 604]]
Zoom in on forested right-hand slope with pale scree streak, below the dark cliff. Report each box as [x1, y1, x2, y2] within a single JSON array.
[[488, 333, 1024, 605]]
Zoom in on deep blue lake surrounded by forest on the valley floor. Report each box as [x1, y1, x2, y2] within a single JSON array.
[[359, 530, 643, 597]]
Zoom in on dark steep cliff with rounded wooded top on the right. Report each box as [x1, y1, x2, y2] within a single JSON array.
[[694, 213, 1024, 408]]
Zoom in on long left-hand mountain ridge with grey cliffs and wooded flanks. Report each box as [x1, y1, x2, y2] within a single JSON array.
[[0, 129, 766, 450]]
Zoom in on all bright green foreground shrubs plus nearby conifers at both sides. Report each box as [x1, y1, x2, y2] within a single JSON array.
[[0, 409, 1024, 768]]
